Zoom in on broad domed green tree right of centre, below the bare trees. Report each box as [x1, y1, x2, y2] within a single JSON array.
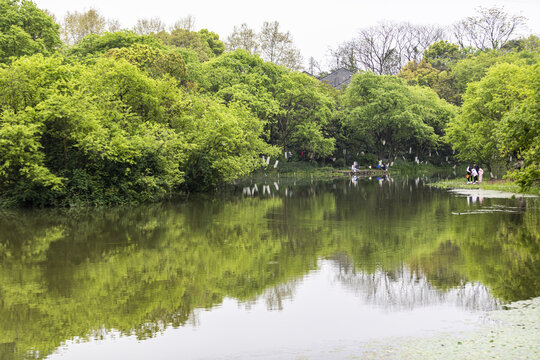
[[343, 72, 455, 159]]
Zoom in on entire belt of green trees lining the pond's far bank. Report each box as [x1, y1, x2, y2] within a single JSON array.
[[0, 0, 540, 206]]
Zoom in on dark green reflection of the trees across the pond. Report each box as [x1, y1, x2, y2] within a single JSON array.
[[0, 179, 540, 358]]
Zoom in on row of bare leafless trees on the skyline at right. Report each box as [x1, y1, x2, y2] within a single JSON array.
[[324, 7, 526, 75]]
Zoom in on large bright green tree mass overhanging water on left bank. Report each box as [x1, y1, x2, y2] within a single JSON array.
[[0, 50, 276, 205]]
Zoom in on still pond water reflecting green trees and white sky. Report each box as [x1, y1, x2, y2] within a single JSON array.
[[0, 178, 540, 359]]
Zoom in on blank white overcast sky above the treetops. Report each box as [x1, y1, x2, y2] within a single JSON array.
[[34, 0, 540, 65]]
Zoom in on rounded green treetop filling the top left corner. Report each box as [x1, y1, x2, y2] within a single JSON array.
[[0, 0, 61, 63]]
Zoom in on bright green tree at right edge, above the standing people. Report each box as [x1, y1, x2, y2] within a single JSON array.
[[447, 63, 538, 171]]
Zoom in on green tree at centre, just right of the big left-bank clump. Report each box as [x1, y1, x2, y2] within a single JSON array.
[[201, 50, 335, 158]]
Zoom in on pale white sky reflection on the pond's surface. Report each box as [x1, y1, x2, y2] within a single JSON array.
[[50, 259, 490, 359]]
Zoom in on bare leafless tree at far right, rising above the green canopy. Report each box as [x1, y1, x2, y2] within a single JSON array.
[[453, 7, 526, 50]]
